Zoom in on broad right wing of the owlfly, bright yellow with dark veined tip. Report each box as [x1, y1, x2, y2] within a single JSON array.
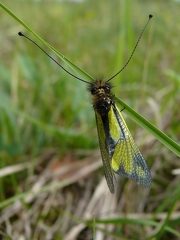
[[109, 106, 152, 188]]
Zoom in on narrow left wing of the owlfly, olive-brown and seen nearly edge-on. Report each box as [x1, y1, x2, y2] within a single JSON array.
[[95, 111, 114, 193]]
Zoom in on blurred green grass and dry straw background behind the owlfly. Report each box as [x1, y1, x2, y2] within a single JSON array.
[[0, 0, 180, 240]]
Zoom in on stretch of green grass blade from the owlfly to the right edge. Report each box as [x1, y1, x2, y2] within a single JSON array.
[[116, 97, 180, 157]]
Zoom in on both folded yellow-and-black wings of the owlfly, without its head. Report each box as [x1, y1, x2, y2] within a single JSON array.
[[95, 104, 152, 193]]
